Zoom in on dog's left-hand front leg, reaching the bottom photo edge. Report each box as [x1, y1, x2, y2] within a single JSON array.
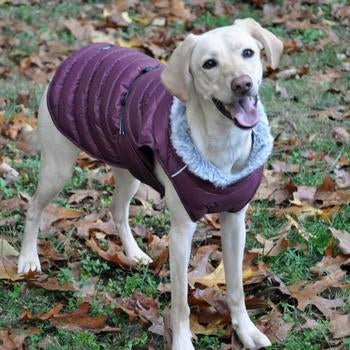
[[166, 187, 196, 350]]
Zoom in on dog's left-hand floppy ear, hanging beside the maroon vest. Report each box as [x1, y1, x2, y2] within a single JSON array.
[[160, 34, 197, 102]]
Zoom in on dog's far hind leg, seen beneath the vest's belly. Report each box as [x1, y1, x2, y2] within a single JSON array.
[[111, 168, 152, 264]]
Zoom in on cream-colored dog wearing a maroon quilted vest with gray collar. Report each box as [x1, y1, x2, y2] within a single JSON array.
[[18, 18, 283, 350]]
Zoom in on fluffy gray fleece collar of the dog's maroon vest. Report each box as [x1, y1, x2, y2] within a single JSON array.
[[170, 97, 273, 187]]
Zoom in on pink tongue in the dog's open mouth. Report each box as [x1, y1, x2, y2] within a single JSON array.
[[231, 96, 259, 128]]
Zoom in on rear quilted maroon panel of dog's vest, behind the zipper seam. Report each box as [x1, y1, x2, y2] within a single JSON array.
[[47, 43, 159, 167]]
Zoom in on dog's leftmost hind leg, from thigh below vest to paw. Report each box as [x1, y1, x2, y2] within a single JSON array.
[[17, 94, 79, 273]]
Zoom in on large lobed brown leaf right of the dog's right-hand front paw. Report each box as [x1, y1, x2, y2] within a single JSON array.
[[287, 270, 345, 317]]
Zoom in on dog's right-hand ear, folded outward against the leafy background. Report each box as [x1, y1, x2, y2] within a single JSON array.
[[234, 18, 283, 69]]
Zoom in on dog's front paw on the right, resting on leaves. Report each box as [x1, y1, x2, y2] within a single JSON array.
[[232, 315, 271, 350]]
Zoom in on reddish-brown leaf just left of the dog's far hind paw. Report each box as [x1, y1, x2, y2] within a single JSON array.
[[85, 238, 137, 268]]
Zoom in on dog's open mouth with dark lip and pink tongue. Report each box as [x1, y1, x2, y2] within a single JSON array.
[[212, 96, 259, 129]]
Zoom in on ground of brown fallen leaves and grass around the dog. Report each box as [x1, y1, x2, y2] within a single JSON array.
[[0, 0, 350, 349]]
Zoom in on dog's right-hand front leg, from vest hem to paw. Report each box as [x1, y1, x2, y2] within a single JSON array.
[[220, 208, 271, 349]]
